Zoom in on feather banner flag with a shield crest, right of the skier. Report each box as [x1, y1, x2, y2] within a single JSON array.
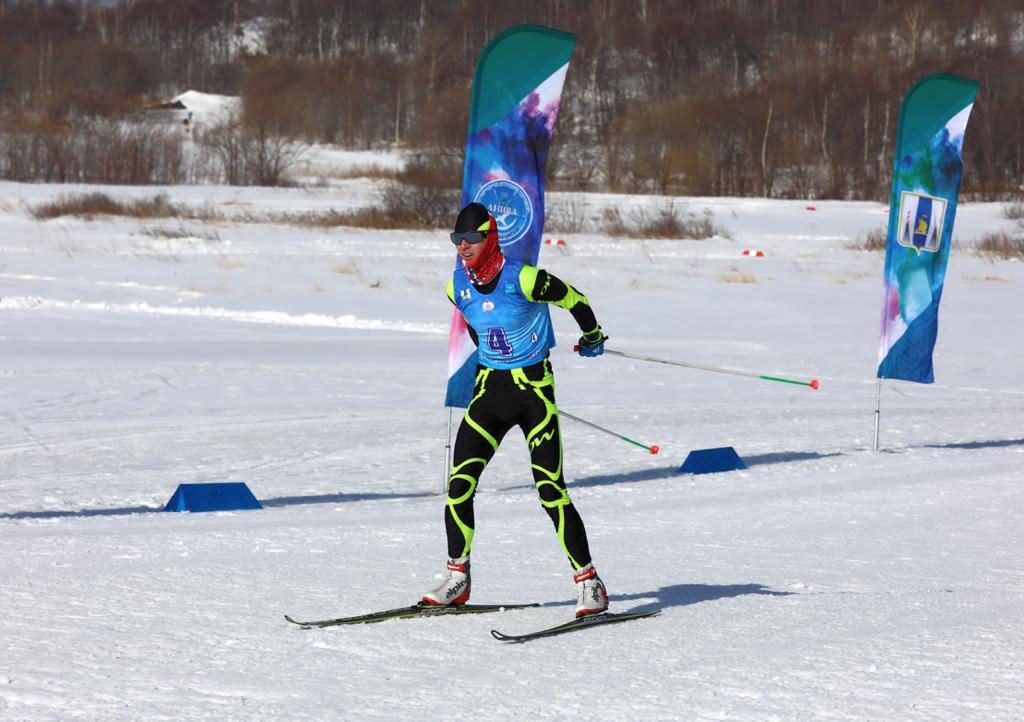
[[878, 74, 978, 383]]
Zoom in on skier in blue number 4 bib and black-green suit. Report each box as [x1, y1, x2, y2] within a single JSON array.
[[423, 203, 608, 617]]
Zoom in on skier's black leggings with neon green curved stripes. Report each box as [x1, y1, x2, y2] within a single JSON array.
[[444, 359, 590, 569]]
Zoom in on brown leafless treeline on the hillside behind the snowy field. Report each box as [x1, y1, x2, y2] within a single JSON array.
[[0, 0, 1024, 200]]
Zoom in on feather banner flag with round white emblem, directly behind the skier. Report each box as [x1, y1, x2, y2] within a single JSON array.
[[444, 25, 575, 408]]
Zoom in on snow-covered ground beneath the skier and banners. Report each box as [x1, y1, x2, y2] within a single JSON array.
[[0, 176, 1024, 720]]
